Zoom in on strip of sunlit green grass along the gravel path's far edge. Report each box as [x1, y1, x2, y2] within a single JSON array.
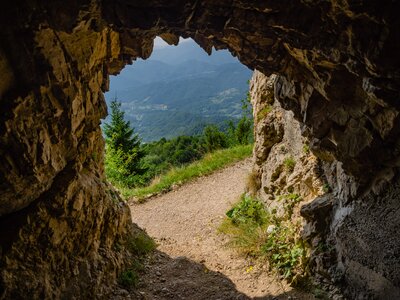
[[120, 145, 253, 202]]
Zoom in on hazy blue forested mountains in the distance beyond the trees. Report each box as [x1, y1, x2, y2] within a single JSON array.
[[105, 41, 251, 141]]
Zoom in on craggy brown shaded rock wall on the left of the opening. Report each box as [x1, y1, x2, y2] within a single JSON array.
[[0, 3, 138, 299]]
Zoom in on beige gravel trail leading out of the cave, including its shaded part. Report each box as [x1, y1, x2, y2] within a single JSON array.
[[131, 159, 310, 300]]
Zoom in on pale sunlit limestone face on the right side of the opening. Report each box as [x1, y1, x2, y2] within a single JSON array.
[[250, 71, 323, 205]]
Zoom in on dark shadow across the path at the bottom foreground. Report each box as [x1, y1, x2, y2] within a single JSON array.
[[125, 251, 313, 300]]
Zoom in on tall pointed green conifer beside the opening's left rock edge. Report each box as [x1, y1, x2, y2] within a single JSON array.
[[103, 99, 147, 187]]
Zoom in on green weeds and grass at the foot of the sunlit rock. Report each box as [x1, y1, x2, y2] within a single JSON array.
[[219, 194, 308, 285]]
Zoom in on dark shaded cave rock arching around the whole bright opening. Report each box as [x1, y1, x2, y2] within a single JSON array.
[[0, 0, 400, 298]]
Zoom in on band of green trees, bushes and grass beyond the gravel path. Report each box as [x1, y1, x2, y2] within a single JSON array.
[[103, 90, 253, 199]]
